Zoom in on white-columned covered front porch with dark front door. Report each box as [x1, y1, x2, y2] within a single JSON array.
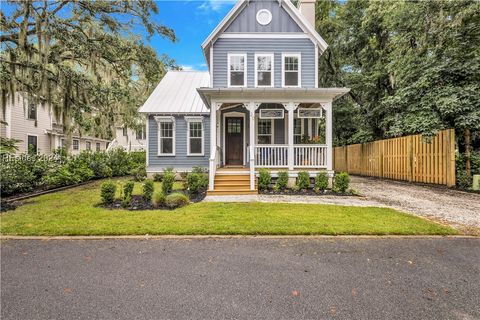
[[199, 88, 348, 194]]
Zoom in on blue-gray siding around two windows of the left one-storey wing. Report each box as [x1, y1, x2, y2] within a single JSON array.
[[147, 114, 210, 172]]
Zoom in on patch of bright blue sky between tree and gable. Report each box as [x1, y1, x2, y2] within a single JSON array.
[[149, 0, 235, 70]]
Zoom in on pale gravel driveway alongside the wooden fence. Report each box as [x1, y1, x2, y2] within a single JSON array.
[[351, 177, 480, 233]]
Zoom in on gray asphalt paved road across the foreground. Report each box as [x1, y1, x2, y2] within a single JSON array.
[[1, 238, 480, 320]]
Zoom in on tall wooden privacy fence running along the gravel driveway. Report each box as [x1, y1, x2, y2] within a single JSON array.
[[334, 129, 455, 187]]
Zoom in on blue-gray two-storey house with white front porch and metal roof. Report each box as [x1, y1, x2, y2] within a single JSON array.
[[140, 0, 349, 195]]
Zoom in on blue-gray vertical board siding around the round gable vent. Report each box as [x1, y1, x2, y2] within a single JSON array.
[[225, 0, 302, 32]]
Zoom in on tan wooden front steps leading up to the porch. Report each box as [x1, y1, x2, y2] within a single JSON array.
[[207, 172, 258, 196]]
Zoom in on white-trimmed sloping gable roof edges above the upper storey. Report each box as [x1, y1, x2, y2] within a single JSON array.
[[202, 0, 328, 60]]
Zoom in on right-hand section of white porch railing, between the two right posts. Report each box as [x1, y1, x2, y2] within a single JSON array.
[[293, 144, 327, 168]]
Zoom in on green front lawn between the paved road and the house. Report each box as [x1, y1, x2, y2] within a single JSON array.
[[0, 182, 457, 236]]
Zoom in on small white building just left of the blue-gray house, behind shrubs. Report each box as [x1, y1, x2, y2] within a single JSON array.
[[108, 125, 147, 152]]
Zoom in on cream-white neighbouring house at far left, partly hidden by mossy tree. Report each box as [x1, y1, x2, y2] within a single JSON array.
[[0, 93, 109, 154]]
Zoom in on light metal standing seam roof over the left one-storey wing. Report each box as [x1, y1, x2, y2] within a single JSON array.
[[139, 71, 210, 114]]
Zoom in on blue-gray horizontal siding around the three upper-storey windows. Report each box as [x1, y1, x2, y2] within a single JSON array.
[[213, 38, 315, 88]]
